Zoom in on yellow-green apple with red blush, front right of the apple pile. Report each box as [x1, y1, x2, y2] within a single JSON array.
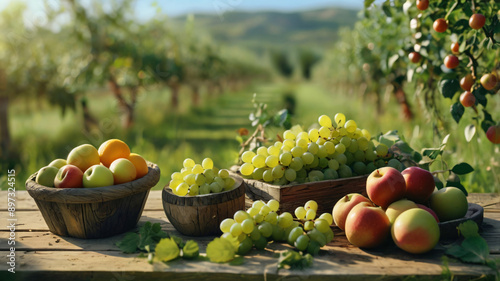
[[391, 208, 440, 254]]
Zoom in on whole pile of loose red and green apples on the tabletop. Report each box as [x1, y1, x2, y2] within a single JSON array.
[[332, 167, 468, 254]]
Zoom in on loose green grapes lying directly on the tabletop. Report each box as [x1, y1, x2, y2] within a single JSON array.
[[220, 199, 333, 255]]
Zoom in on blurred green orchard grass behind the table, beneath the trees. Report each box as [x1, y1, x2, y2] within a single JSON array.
[[0, 82, 500, 192]]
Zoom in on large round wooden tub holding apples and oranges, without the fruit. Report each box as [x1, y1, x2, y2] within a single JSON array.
[[26, 162, 160, 238]]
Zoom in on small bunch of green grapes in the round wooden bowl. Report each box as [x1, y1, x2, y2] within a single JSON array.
[[169, 158, 235, 196]]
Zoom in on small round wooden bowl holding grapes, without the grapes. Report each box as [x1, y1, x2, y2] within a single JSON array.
[[162, 176, 245, 236]]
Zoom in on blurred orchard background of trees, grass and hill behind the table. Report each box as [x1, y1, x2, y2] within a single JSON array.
[[0, 0, 500, 192]]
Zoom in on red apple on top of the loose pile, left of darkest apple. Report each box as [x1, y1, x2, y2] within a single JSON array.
[[366, 167, 406, 209]]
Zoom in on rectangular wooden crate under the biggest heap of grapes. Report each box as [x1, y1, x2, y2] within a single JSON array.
[[240, 171, 368, 216]]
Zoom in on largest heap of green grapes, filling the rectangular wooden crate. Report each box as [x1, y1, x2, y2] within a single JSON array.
[[240, 113, 404, 185]]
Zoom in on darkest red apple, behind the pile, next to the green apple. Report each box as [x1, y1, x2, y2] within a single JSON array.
[[401, 167, 436, 203]]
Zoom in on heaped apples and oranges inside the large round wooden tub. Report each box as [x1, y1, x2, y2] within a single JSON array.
[[35, 139, 148, 188]]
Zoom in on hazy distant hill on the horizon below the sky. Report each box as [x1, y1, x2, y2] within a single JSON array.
[[175, 8, 358, 49]]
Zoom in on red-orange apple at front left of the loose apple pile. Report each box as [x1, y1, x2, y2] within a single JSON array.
[[345, 202, 391, 248]]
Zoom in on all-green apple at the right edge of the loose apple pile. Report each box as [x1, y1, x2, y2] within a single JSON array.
[[429, 186, 469, 222]]
